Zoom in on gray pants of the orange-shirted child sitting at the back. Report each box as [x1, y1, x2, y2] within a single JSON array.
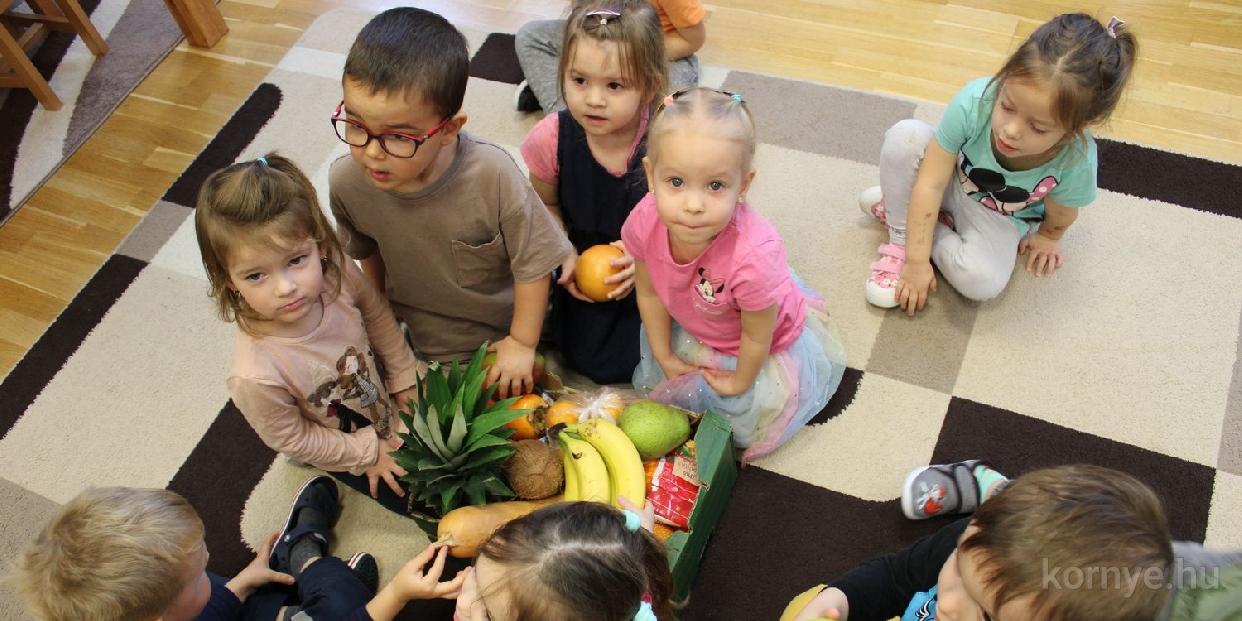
[[514, 20, 699, 113]]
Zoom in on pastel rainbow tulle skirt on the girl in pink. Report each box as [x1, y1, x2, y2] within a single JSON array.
[[633, 282, 846, 461]]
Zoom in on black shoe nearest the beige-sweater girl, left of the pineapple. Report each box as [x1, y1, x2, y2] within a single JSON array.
[[267, 476, 340, 578]]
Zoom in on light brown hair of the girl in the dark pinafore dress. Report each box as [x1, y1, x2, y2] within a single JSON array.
[[556, 0, 668, 107]]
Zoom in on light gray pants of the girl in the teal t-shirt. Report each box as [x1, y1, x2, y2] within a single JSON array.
[[879, 119, 1022, 301]]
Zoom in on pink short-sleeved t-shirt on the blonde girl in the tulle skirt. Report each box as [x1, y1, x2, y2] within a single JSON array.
[[621, 193, 806, 355]]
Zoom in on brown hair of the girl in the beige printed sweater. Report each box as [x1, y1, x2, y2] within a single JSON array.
[[194, 153, 344, 332]]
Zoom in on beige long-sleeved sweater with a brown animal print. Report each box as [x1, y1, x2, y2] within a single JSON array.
[[229, 260, 426, 474]]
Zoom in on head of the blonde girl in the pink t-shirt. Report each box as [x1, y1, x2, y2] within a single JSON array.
[[642, 87, 755, 251]]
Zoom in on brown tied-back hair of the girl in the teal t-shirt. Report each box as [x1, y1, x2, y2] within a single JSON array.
[[987, 12, 1138, 143]]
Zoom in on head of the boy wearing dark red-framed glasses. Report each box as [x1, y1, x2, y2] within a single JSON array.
[[333, 6, 469, 191]]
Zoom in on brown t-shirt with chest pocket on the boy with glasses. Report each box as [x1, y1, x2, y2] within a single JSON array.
[[329, 133, 573, 360]]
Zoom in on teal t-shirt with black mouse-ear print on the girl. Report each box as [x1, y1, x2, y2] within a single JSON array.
[[935, 77, 1098, 232]]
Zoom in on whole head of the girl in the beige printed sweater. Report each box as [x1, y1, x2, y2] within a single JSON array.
[[194, 153, 344, 333]]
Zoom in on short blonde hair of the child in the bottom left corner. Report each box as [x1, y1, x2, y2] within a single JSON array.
[[14, 487, 204, 621]]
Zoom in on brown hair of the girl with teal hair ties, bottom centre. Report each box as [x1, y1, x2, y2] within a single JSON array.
[[479, 502, 674, 621]]
